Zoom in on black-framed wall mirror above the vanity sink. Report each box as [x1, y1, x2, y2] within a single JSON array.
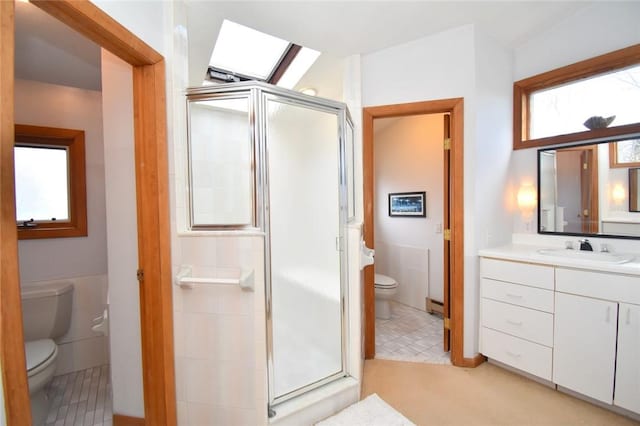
[[538, 135, 640, 239]]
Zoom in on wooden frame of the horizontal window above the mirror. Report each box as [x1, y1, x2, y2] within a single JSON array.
[[513, 44, 640, 150]]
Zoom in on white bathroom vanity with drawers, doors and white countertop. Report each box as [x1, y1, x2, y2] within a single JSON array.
[[480, 245, 640, 414]]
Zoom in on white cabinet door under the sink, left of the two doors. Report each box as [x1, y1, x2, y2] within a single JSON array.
[[553, 293, 618, 404]]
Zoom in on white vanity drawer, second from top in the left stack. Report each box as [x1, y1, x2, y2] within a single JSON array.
[[481, 278, 553, 313]]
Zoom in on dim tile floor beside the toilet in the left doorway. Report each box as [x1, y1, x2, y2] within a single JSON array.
[[45, 365, 113, 426]]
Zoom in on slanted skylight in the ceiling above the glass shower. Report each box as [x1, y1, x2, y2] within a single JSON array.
[[205, 19, 320, 89]]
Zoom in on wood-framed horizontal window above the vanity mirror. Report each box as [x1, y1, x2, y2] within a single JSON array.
[[513, 45, 640, 149]]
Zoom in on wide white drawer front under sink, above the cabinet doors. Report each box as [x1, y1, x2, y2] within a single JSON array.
[[556, 268, 640, 305]]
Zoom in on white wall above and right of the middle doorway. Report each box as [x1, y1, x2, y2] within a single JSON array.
[[362, 25, 511, 357]]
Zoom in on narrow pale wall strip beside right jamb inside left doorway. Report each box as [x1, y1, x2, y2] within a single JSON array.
[[102, 50, 144, 417]]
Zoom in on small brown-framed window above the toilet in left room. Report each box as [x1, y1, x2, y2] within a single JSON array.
[[14, 124, 87, 239]]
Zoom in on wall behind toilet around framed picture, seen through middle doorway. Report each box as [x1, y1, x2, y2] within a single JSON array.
[[374, 114, 444, 311]]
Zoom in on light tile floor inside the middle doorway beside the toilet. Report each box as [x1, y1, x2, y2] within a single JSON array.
[[376, 301, 451, 364]]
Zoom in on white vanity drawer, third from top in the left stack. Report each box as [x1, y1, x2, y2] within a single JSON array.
[[482, 299, 553, 347]]
